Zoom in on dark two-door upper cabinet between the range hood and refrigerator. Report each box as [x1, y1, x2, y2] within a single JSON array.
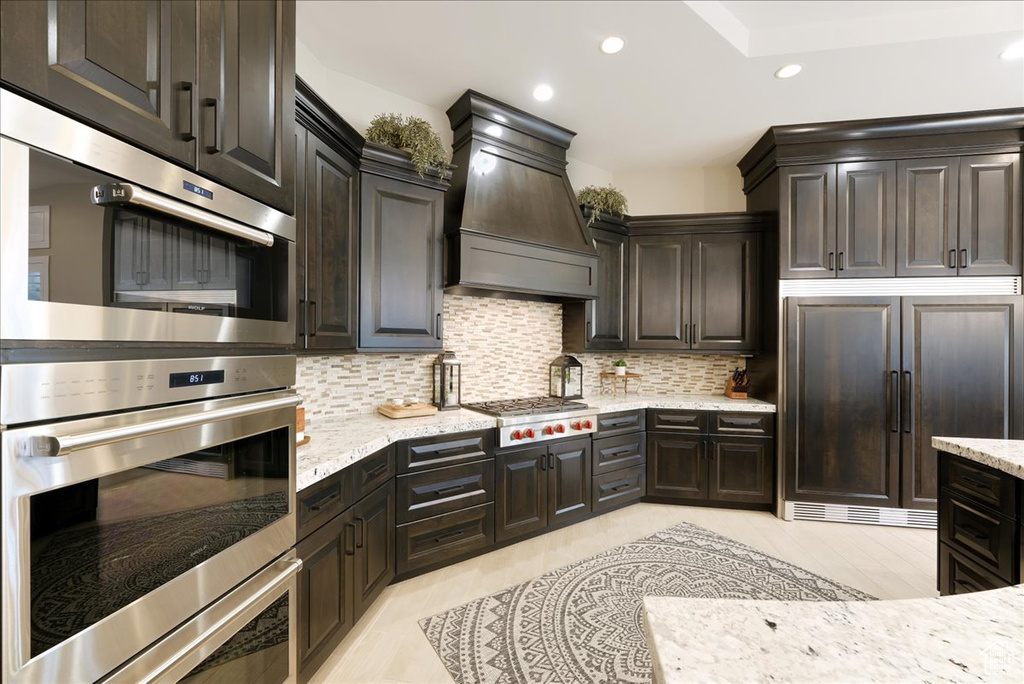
[[629, 214, 767, 353]]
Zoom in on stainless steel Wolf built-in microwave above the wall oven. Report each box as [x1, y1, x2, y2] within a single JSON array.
[[0, 90, 296, 346]]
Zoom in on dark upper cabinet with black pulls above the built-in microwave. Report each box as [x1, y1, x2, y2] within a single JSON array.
[[0, 0, 295, 214]]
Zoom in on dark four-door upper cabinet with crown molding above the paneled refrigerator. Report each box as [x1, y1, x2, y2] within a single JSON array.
[[738, 109, 1024, 279]]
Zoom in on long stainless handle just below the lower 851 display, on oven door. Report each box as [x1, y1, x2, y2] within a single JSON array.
[[18, 396, 302, 457]]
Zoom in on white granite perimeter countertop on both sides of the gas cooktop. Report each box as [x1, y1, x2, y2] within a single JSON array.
[[295, 394, 775, 491]]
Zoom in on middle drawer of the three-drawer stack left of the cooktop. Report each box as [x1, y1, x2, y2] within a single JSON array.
[[397, 460, 495, 524]]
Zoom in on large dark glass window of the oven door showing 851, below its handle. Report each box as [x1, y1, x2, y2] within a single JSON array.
[[31, 428, 290, 656]]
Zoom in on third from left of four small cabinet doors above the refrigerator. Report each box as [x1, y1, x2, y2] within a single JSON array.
[[896, 157, 959, 275]]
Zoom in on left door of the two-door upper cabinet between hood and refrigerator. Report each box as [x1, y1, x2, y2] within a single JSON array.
[[629, 236, 690, 349]]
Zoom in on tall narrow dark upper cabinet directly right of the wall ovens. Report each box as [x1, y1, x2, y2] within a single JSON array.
[[295, 79, 364, 352]]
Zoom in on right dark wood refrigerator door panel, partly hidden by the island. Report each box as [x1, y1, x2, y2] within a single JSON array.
[[901, 296, 1024, 509]]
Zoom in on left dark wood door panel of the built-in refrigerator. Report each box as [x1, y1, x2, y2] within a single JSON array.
[[784, 297, 900, 507]]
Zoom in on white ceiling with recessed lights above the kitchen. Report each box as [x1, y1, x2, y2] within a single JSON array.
[[297, 0, 1024, 171]]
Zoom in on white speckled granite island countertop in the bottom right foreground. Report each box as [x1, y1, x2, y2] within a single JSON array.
[[644, 585, 1024, 684]]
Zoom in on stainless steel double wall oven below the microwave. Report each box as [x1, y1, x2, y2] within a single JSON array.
[[0, 355, 301, 684]]
